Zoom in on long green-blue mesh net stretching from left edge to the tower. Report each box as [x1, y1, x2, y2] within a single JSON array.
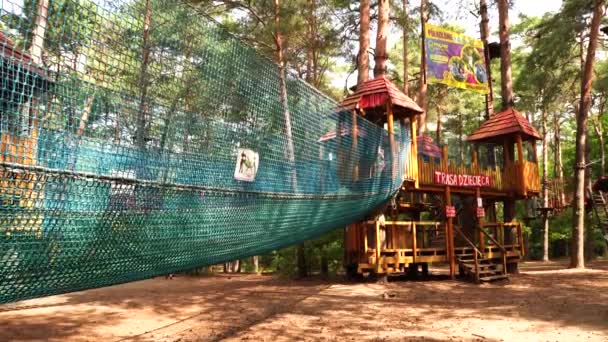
[[0, 0, 409, 302]]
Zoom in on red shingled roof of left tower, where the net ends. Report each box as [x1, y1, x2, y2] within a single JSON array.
[[340, 76, 424, 115]]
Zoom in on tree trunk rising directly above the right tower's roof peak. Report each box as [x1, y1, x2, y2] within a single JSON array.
[[498, 0, 513, 109]]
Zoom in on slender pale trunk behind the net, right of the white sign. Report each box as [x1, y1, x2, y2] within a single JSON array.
[[274, 0, 298, 193]]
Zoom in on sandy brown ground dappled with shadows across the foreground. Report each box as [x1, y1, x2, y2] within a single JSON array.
[[0, 262, 608, 342]]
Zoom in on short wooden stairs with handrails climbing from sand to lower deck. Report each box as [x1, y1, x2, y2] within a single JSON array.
[[454, 226, 509, 283]]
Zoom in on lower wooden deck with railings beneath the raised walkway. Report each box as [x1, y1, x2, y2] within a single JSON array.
[[345, 221, 524, 274]]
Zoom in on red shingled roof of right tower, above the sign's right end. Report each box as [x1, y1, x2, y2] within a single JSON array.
[[467, 108, 541, 142]]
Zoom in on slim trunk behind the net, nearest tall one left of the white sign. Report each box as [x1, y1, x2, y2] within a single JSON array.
[[135, 0, 151, 149]]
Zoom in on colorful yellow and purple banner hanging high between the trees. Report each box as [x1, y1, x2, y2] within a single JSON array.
[[425, 24, 488, 94]]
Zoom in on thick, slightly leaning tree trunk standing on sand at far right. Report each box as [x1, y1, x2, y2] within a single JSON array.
[[570, 0, 604, 268]]
